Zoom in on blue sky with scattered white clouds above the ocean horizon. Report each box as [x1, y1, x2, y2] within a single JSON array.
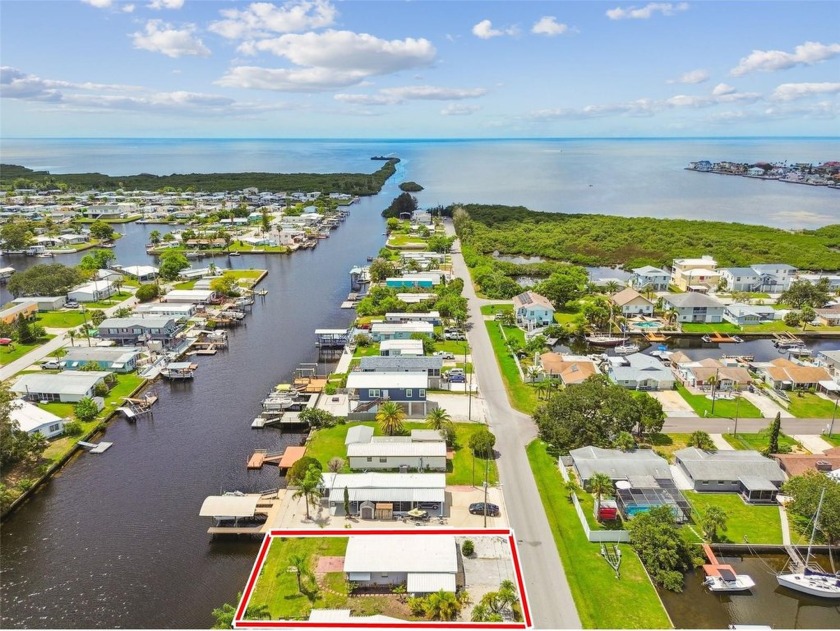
[[0, 0, 840, 138]]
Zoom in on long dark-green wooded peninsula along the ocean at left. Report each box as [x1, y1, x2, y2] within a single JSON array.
[[0, 158, 400, 196]]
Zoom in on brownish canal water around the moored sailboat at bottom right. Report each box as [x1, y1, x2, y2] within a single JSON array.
[[659, 554, 840, 629]]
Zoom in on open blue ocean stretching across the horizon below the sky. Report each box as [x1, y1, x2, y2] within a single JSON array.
[[0, 138, 840, 229]]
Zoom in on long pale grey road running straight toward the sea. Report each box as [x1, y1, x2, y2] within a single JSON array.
[[446, 221, 581, 629]]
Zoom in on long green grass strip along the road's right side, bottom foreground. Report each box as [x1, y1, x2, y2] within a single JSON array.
[[528, 440, 671, 629]]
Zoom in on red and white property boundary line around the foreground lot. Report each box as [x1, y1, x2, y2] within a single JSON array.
[[233, 528, 533, 629]]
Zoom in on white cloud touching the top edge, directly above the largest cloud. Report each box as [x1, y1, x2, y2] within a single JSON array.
[[209, 0, 338, 39]]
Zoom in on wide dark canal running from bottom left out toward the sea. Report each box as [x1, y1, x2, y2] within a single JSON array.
[[0, 183, 394, 628]]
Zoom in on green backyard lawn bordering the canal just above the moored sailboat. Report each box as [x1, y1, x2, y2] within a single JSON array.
[[682, 491, 782, 544]]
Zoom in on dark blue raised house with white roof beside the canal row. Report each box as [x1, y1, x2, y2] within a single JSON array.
[[347, 371, 429, 418]]
